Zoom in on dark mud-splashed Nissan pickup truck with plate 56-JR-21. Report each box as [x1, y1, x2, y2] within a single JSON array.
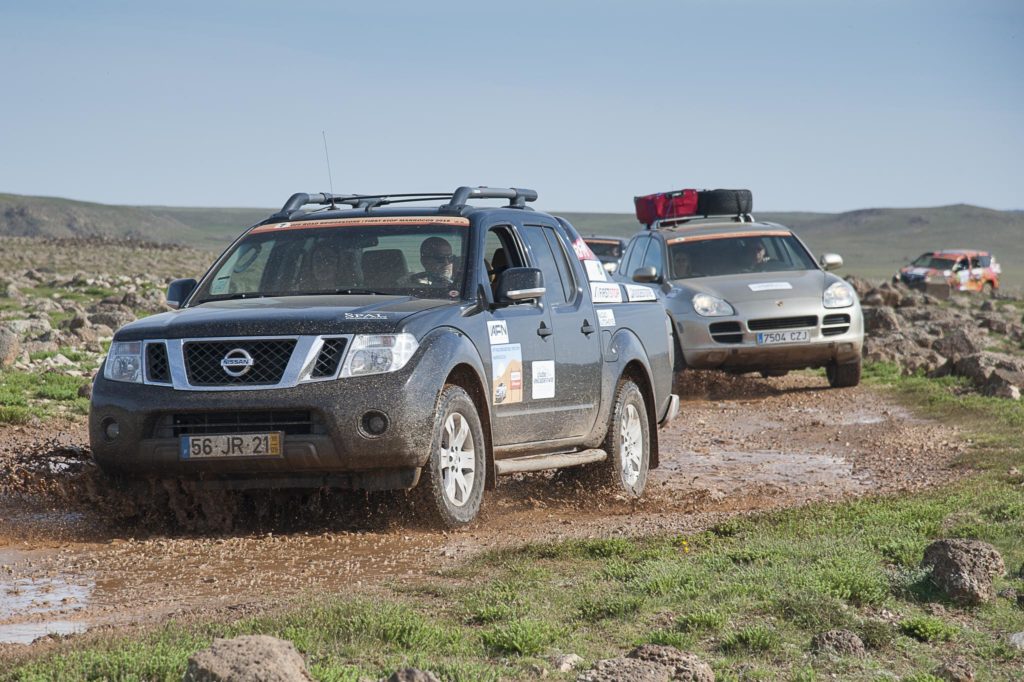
[[89, 187, 679, 527]]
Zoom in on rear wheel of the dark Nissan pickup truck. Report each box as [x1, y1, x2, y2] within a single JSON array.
[[599, 379, 650, 498]]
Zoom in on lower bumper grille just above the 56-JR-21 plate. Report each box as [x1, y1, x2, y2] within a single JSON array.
[[153, 410, 317, 438]]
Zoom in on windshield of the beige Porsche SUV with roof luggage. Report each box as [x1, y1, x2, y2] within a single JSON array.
[[669, 235, 817, 280]]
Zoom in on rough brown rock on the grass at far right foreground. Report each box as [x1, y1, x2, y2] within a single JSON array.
[[921, 540, 1007, 604]]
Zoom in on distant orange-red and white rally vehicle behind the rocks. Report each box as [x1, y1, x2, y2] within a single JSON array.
[[893, 249, 1002, 294]]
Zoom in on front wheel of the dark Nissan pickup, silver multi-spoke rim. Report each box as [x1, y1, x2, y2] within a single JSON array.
[[416, 385, 487, 529]]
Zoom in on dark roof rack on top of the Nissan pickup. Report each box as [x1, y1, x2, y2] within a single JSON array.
[[268, 185, 537, 220]]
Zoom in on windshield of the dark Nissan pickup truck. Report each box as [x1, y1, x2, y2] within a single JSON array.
[[194, 223, 469, 304]]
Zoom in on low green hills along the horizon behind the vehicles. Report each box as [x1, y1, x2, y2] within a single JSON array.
[[0, 195, 1024, 289]]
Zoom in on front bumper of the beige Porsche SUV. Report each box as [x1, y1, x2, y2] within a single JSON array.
[[675, 302, 864, 372]]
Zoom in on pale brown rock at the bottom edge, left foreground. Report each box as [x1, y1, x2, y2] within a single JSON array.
[[182, 635, 312, 682]]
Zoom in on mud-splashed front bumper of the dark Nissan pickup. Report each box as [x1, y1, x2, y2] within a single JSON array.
[[89, 364, 437, 488]]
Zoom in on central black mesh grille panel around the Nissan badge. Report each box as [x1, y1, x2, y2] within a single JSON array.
[[184, 339, 295, 386]]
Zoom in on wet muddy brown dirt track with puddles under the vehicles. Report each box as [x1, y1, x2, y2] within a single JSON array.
[[0, 373, 966, 653]]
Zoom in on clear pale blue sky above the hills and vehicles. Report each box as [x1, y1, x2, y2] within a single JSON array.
[[0, 0, 1024, 212]]
